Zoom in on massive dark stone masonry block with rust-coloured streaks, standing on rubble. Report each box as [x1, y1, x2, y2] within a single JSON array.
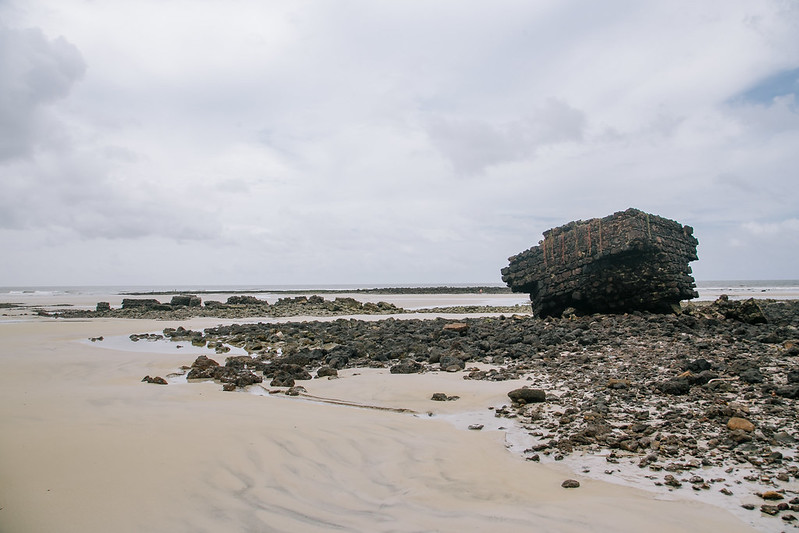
[[502, 209, 699, 316]]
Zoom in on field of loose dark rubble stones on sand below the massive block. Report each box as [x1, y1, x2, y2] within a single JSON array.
[[128, 297, 799, 524]]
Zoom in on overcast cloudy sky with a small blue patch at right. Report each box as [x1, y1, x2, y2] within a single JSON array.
[[0, 0, 799, 286]]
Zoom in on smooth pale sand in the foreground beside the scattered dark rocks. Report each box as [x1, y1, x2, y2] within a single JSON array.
[[0, 304, 764, 532]]
